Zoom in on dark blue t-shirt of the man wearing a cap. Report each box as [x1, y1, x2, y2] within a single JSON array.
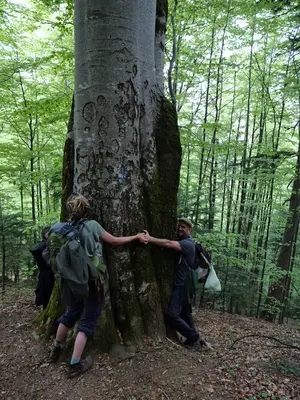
[[174, 236, 195, 286]]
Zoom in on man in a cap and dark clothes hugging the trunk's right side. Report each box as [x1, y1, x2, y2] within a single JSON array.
[[144, 218, 206, 351]]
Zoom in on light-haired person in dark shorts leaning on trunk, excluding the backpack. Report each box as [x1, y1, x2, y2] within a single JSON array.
[[49, 194, 145, 378]]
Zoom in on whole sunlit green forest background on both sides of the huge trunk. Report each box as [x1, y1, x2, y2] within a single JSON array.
[[0, 0, 300, 323]]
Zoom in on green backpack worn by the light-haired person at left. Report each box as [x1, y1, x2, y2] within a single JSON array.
[[48, 221, 99, 306]]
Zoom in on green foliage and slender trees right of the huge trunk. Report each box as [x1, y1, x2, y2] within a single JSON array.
[[167, 0, 300, 315]]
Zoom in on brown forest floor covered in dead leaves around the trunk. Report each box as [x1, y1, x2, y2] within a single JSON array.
[[0, 288, 300, 400]]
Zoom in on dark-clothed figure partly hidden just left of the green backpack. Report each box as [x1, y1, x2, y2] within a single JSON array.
[[30, 226, 54, 309]]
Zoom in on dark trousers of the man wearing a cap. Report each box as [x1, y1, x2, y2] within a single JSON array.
[[165, 286, 199, 343]]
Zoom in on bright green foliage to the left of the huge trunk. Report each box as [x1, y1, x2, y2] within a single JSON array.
[[0, 1, 74, 276]]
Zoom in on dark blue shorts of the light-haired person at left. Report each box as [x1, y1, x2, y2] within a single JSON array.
[[59, 293, 102, 336]]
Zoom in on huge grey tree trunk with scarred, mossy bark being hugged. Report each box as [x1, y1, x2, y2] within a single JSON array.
[[39, 0, 181, 347]]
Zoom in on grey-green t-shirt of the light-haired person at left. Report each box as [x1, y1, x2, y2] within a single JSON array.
[[81, 220, 106, 260]]
